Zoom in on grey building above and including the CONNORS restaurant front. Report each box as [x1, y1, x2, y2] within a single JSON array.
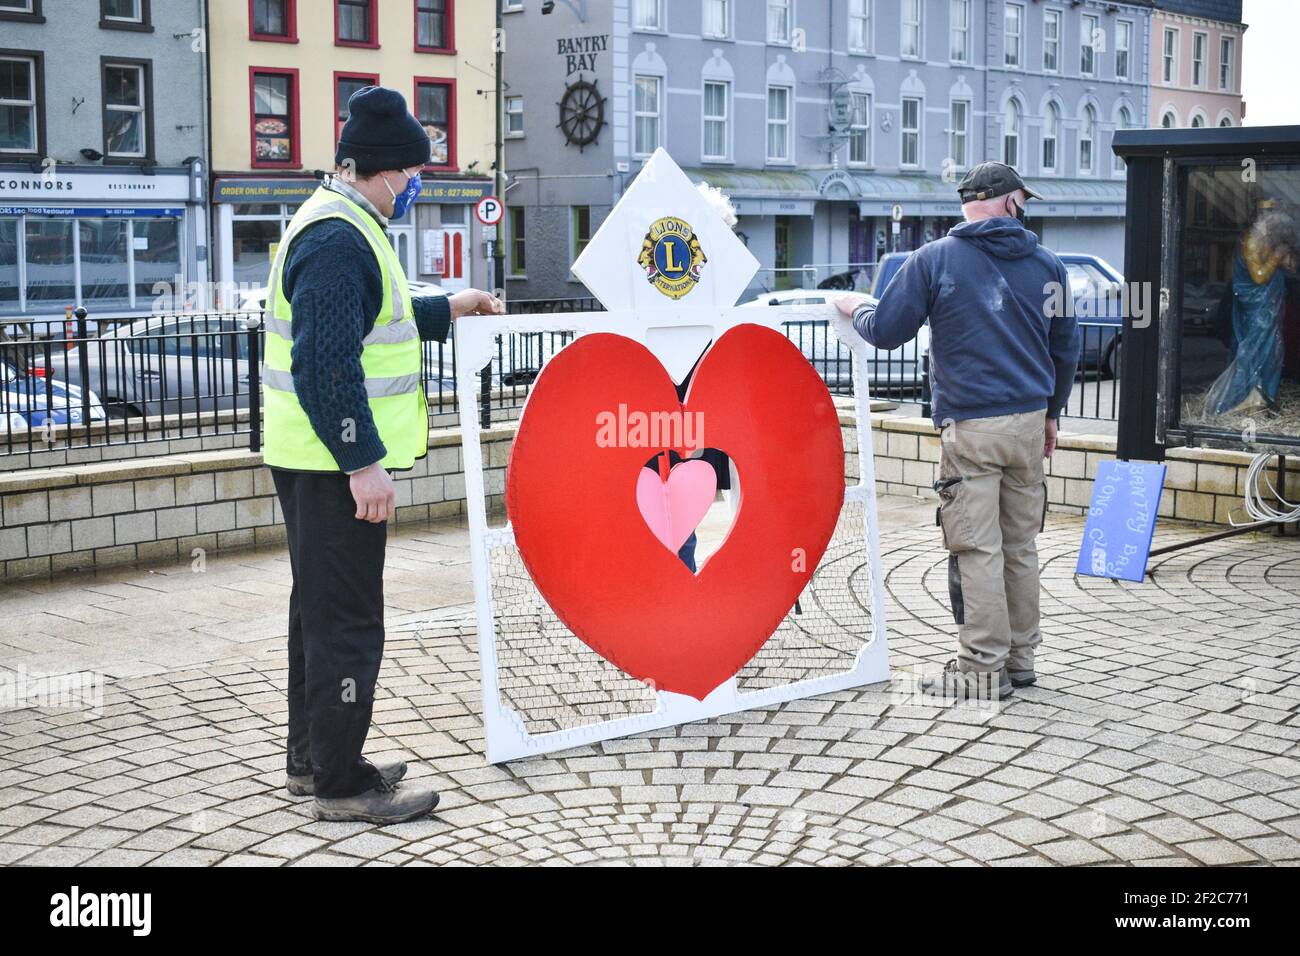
[[0, 0, 208, 319]]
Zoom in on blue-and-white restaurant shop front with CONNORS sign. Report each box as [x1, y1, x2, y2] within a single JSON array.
[[0, 161, 207, 320]]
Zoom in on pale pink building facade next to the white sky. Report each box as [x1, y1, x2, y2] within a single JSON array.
[[1149, 0, 1245, 129]]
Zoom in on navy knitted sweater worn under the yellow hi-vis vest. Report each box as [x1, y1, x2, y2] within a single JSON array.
[[283, 219, 451, 472]]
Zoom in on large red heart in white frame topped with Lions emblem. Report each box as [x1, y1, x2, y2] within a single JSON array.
[[455, 150, 888, 762]]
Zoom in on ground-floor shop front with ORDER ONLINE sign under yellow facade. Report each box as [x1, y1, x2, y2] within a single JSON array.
[[212, 177, 491, 307]]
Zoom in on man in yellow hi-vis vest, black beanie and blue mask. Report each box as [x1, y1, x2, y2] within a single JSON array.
[[263, 87, 504, 823]]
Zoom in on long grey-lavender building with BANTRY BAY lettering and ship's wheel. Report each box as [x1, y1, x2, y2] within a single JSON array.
[[504, 0, 1151, 298]]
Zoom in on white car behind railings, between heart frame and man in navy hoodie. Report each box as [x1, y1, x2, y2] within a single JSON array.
[[741, 289, 930, 394]]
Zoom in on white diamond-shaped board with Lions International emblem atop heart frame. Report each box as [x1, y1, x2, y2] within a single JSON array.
[[573, 147, 758, 310]]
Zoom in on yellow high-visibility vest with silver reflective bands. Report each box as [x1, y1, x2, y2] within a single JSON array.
[[261, 187, 429, 471]]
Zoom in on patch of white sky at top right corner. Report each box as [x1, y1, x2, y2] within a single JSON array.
[[1242, 0, 1300, 126]]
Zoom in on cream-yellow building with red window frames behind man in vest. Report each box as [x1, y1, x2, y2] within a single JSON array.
[[209, 0, 495, 303]]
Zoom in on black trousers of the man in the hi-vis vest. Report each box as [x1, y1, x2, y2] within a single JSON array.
[[272, 468, 389, 797]]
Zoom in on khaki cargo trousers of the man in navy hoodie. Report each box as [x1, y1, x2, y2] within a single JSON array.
[[935, 411, 1047, 671]]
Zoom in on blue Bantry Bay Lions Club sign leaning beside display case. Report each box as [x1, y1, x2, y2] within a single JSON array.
[[1075, 462, 1165, 581]]
